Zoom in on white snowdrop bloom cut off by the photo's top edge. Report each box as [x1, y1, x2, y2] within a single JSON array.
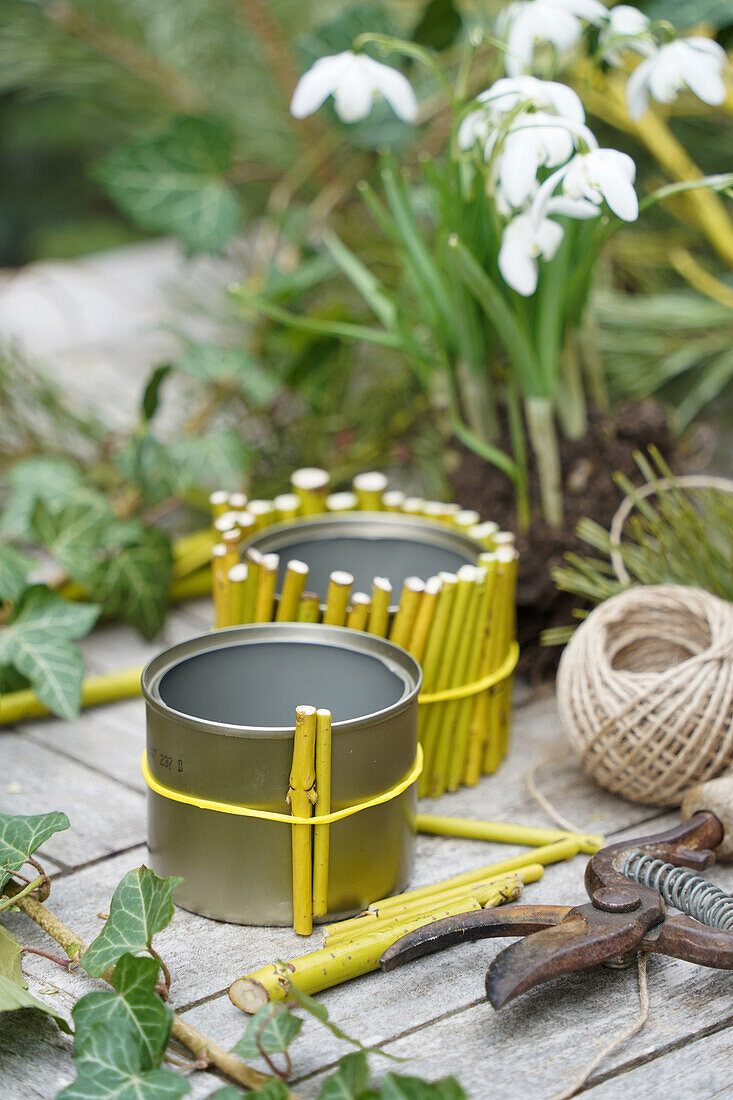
[[496, 0, 606, 76]]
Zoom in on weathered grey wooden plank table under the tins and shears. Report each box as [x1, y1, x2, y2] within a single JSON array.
[[0, 602, 733, 1100]]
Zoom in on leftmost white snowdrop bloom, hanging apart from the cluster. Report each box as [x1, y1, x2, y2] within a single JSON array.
[[291, 50, 417, 122]]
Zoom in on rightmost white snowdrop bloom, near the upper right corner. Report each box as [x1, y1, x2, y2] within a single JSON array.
[[626, 36, 726, 119]]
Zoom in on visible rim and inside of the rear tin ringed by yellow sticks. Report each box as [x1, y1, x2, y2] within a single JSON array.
[[245, 512, 483, 595]]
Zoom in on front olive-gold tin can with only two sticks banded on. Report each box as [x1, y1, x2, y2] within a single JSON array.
[[142, 623, 422, 925]]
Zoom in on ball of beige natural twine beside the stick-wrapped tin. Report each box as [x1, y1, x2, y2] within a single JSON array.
[[557, 584, 733, 806]]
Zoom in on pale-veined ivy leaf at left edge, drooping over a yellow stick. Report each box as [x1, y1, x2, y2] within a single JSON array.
[[0, 584, 100, 718]]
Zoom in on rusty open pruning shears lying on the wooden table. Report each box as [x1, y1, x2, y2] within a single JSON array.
[[380, 777, 733, 1009]]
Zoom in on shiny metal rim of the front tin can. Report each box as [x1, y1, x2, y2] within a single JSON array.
[[142, 623, 423, 738]]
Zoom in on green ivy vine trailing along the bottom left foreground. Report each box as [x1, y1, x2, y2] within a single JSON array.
[[0, 813, 466, 1100]]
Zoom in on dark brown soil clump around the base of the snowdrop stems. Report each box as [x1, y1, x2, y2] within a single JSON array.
[[451, 400, 674, 681]]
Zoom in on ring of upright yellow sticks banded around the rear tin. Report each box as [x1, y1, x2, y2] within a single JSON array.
[[210, 468, 518, 796]]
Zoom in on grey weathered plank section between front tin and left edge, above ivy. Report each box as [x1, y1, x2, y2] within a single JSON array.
[[0, 732, 145, 867]]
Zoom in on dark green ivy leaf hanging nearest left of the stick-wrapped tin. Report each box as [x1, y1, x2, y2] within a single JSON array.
[[87, 524, 173, 638]]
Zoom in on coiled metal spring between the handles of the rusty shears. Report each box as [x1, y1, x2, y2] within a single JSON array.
[[623, 850, 733, 928]]
